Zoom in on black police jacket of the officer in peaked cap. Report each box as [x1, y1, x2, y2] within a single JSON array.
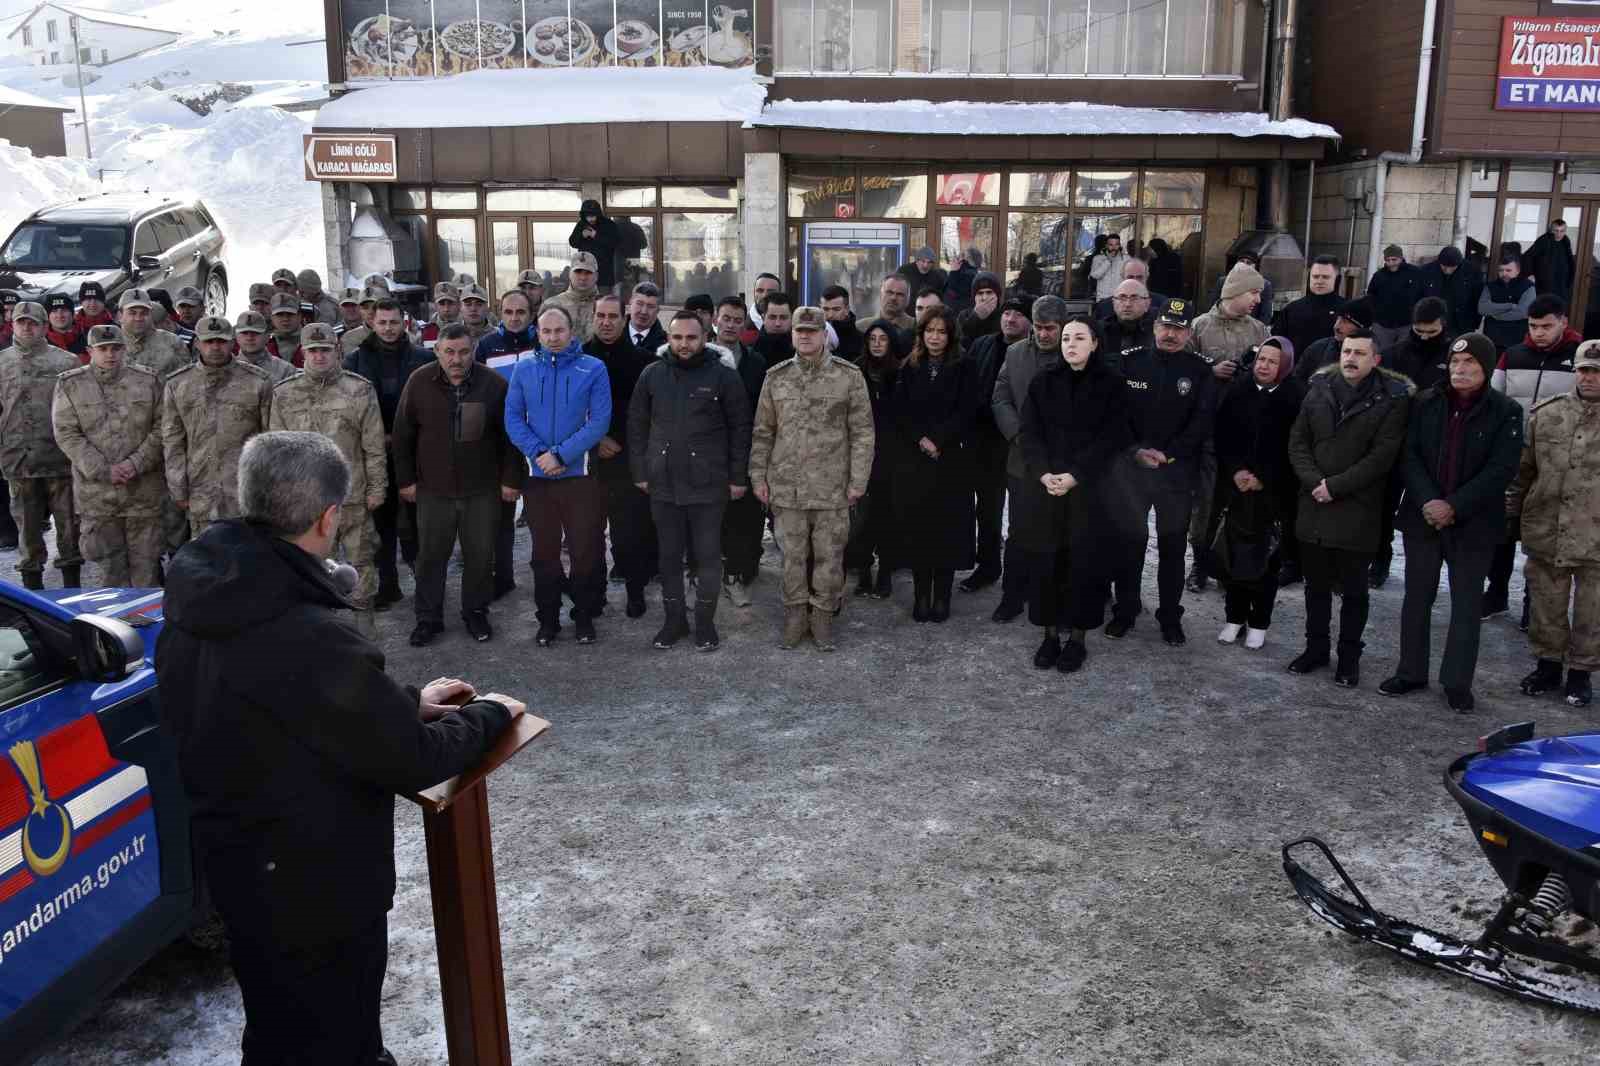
[[1122, 344, 1214, 477]]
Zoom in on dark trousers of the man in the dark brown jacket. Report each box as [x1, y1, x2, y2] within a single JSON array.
[[416, 493, 501, 624]]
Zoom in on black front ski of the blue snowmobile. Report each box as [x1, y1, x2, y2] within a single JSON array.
[[1283, 837, 1600, 1013]]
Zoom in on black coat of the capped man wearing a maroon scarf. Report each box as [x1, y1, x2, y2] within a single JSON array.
[[1395, 384, 1522, 547]]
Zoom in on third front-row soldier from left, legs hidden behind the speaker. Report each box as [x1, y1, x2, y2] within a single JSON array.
[[162, 315, 272, 536]]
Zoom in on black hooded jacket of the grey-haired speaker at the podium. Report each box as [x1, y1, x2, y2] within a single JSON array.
[[155, 520, 510, 951]]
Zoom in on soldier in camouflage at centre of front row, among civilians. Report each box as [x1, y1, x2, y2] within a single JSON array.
[[750, 307, 875, 651]]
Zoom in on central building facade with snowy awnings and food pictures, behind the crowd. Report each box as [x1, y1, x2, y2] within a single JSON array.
[[315, 0, 1334, 314]]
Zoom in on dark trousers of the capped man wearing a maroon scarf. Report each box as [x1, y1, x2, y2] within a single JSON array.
[[1395, 533, 1494, 688]]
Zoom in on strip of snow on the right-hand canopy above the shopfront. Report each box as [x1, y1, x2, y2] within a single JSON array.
[[747, 99, 1339, 141]]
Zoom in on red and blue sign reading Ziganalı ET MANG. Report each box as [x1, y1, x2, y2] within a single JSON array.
[[1494, 16, 1600, 110]]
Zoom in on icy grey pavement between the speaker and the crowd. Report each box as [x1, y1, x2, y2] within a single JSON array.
[[21, 533, 1600, 1066]]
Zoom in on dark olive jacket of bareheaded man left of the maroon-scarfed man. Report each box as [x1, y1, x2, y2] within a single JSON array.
[[1290, 367, 1411, 552]]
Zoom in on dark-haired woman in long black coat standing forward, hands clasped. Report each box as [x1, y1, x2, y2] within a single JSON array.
[[1011, 317, 1133, 674]]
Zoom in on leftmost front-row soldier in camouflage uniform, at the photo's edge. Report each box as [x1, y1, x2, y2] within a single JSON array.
[[0, 303, 83, 589]]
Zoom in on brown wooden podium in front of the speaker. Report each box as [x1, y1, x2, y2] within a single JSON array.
[[406, 695, 550, 1066]]
